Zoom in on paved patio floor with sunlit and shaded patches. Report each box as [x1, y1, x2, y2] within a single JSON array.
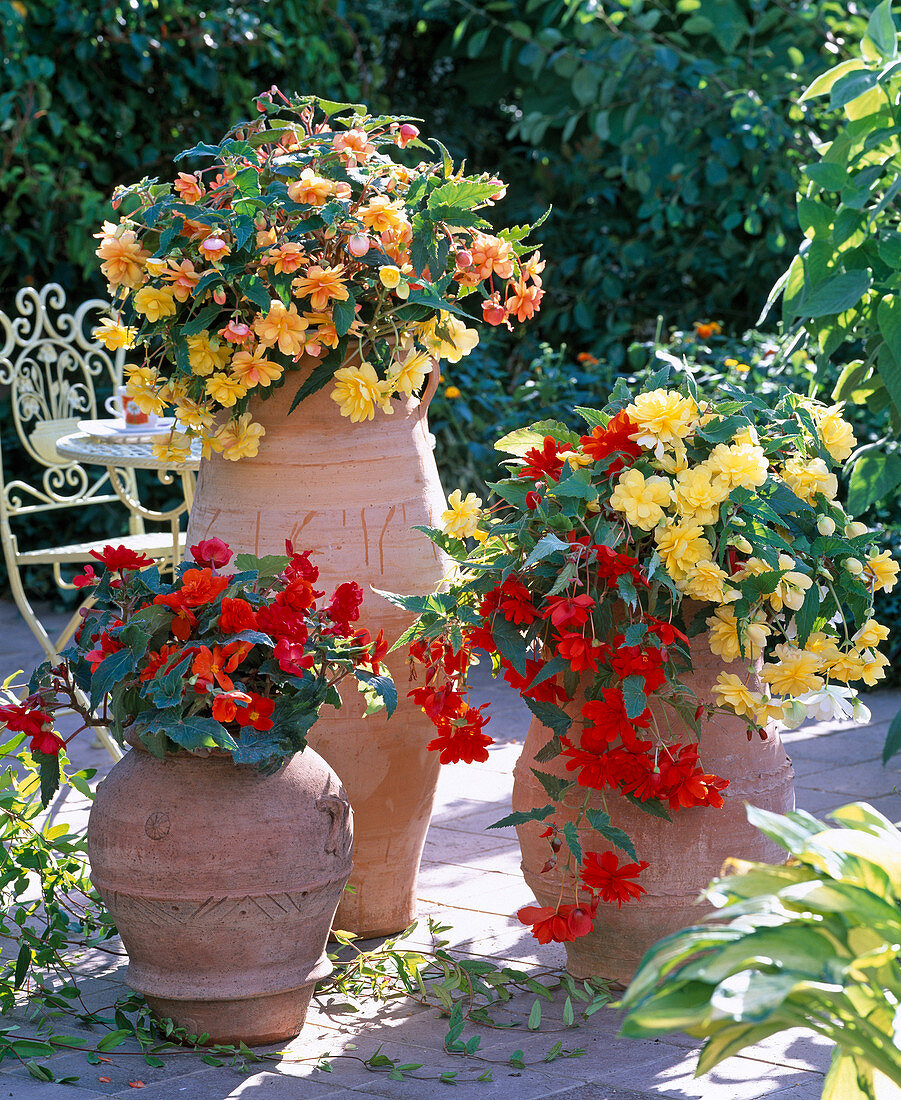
[[0, 602, 901, 1100]]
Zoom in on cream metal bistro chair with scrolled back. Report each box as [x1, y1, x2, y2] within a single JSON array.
[[0, 283, 183, 756]]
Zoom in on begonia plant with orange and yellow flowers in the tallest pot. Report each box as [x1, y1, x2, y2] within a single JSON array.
[[96, 88, 545, 460]]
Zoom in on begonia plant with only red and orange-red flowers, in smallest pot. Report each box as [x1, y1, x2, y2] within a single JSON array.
[[0, 538, 397, 804]]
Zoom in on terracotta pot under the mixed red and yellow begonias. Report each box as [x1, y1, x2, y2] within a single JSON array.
[[513, 620, 794, 985]]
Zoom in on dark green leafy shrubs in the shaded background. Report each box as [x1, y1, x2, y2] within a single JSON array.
[[0, 0, 901, 677]]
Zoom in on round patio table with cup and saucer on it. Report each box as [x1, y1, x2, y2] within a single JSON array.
[[56, 431, 200, 551]]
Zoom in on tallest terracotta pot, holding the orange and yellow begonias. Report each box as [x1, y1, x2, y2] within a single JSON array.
[[187, 369, 447, 936]]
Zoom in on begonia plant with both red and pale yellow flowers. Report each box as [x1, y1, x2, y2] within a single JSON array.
[[392, 366, 899, 942]]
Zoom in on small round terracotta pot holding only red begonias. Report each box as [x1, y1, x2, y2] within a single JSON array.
[[88, 748, 353, 1045]]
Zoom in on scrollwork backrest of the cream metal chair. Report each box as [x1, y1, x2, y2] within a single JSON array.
[[0, 283, 124, 515]]
